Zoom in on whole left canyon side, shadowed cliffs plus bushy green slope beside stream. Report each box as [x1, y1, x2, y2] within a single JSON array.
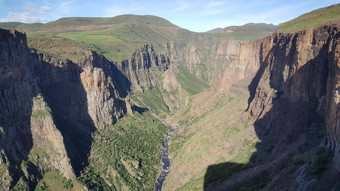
[[0, 29, 173, 190]]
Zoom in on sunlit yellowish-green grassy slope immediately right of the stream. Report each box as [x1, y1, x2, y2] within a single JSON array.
[[164, 92, 258, 190]]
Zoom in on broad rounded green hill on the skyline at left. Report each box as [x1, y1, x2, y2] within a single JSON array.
[[4, 15, 186, 61]]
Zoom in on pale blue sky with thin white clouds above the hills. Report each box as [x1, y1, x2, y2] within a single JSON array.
[[0, 0, 340, 32]]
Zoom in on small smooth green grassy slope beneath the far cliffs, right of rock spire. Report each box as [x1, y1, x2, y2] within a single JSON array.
[[177, 65, 209, 95]]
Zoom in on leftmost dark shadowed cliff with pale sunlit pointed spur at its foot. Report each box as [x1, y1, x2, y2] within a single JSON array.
[[0, 29, 74, 190]]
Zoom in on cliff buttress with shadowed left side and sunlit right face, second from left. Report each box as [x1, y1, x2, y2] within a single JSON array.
[[34, 51, 130, 175]]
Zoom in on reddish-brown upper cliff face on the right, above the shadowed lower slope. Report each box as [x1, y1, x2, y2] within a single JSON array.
[[249, 25, 340, 148]]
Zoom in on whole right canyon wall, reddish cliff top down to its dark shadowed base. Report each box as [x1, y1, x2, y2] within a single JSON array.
[[206, 21, 340, 190]]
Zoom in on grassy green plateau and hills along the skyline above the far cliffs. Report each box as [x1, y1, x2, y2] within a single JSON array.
[[0, 15, 270, 62]]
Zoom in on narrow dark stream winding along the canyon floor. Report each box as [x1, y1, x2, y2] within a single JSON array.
[[155, 126, 174, 191]]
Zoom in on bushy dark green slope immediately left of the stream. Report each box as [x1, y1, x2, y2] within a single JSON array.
[[80, 112, 168, 190]]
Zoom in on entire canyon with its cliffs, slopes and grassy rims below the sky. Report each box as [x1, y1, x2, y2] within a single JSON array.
[[0, 5, 340, 190]]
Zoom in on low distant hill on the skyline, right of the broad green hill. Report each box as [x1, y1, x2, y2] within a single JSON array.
[[207, 23, 279, 40]]
